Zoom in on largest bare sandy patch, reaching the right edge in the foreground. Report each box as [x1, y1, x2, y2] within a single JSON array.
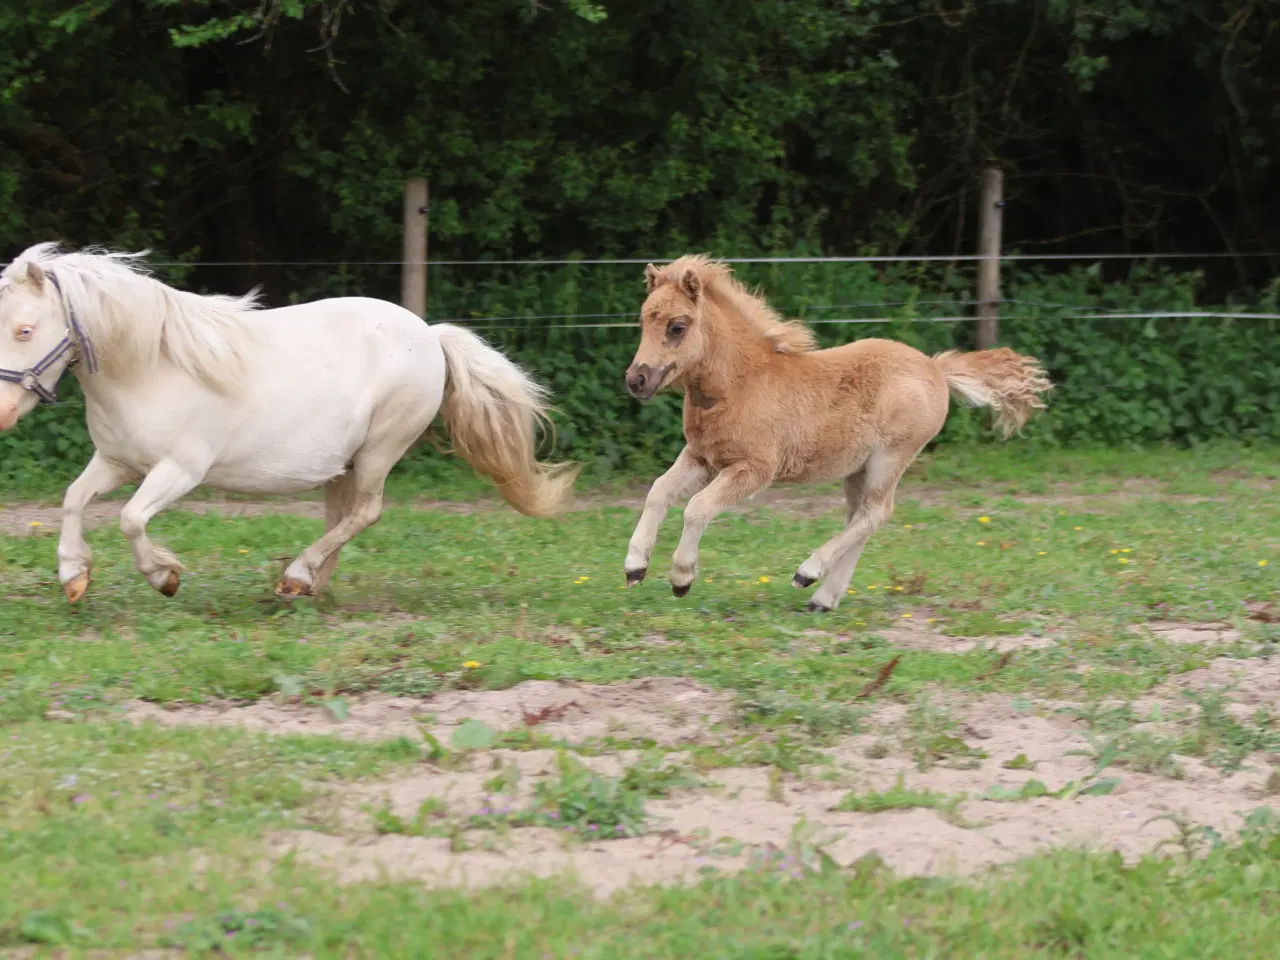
[[264, 675, 1280, 895]]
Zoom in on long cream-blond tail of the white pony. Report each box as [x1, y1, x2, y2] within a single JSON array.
[[431, 324, 581, 517]]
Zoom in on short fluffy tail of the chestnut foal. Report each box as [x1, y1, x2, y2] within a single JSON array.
[[933, 347, 1053, 439]]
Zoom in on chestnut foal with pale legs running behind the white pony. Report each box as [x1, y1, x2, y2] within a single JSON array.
[[625, 256, 1051, 611]]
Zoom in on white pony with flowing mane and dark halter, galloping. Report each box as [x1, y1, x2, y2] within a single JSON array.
[[0, 243, 577, 603]]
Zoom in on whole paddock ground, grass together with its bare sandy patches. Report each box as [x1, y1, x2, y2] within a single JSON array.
[[0, 445, 1280, 960]]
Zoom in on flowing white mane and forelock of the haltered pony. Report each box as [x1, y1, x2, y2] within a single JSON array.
[[0, 243, 259, 394]]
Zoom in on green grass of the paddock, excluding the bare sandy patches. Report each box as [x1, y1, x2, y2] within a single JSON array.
[[0, 445, 1280, 960]]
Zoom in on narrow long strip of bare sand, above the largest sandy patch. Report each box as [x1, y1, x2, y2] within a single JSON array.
[[125, 677, 731, 745]]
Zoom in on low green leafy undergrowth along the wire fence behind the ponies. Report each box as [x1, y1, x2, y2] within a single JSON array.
[[0, 264, 1280, 486]]
